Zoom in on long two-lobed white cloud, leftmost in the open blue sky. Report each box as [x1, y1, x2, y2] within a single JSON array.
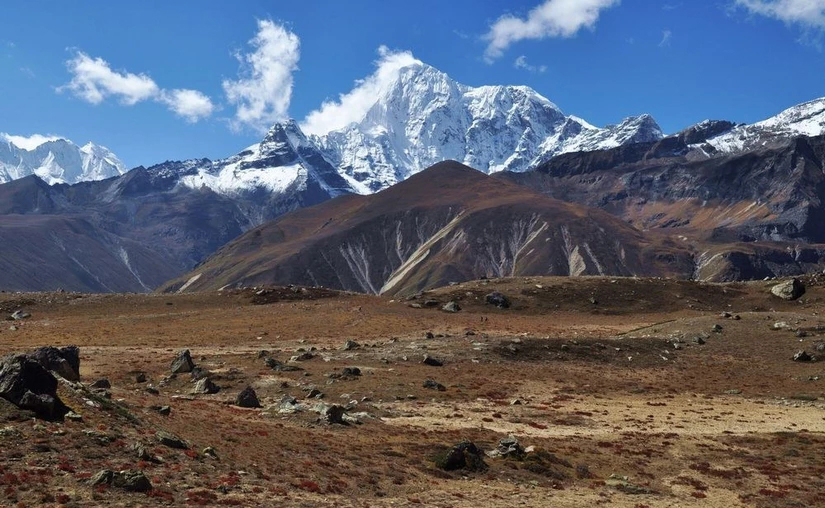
[[57, 51, 215, 122]]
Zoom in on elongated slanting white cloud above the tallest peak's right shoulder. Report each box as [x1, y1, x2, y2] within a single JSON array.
[[484, 0, 621, 63]]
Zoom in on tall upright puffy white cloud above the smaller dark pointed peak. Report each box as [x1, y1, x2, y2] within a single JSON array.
[[223, 20, 301, 131]]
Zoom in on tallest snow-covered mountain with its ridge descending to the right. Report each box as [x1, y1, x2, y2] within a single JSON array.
[[311, 63, 663, 193]]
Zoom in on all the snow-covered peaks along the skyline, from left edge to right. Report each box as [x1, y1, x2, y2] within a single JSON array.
[[0, 62, 825, 202]]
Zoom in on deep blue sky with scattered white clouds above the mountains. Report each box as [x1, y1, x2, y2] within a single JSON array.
[[0, 0, 825, 167]]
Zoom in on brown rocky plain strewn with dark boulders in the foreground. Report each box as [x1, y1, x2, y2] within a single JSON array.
[[0, 277, 825, 508]]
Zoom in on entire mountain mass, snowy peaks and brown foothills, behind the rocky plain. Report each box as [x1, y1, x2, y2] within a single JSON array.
[[0, 62, 825, 294]]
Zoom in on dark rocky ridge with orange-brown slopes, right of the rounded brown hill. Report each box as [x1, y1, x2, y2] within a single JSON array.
[[496, 133, 825, 281]]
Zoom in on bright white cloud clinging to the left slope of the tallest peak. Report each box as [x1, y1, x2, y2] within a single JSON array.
[[301, 46, 422, 136]]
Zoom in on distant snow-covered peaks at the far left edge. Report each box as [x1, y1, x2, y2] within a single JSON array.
[[0, 133, 126, 185]]
